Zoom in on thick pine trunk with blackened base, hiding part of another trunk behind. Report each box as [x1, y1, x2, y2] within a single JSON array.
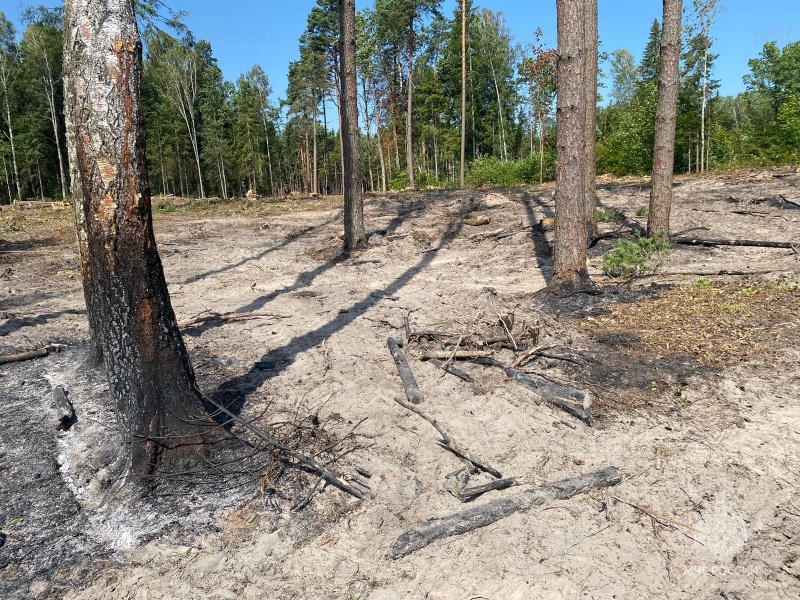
[[548, 0, 591, 292]]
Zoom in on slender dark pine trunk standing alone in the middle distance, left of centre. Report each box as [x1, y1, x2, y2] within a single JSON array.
[[339, 0, 366, 250]]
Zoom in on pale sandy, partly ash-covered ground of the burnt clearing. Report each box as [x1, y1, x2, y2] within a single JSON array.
[[0, 171, 800, 600]]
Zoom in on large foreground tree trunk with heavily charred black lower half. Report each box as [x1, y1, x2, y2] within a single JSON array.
[[64, 0, 209, 478]]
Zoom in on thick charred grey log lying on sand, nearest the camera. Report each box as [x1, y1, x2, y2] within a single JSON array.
[[386, 467, 622, 559]]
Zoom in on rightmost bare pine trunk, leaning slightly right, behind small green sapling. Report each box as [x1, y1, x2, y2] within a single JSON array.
[[647, 0, 683, 240]]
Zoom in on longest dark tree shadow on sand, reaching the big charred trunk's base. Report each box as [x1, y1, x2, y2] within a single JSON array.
[[209, 216, 462, 415]]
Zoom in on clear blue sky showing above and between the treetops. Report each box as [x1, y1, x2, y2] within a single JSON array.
[[4, 0, 800, 104]]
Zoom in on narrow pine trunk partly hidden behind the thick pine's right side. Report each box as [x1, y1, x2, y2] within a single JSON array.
[[585, 0, 597, 237]]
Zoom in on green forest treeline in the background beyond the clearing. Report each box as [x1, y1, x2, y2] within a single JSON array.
[[0, 0, 800, 202]]
